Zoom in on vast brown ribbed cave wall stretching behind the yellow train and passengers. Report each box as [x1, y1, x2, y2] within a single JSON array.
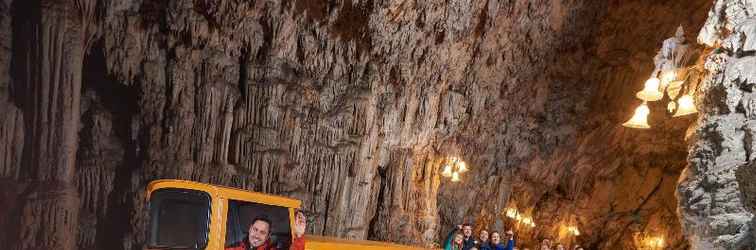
[[0, 0, 736, 249]]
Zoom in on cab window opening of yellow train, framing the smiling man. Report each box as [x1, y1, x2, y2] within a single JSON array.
[[225, 200, 291, 249]]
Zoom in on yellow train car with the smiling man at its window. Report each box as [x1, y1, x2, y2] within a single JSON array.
[[145, 180, 432, 250]]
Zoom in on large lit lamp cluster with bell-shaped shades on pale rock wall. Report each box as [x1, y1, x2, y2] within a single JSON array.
[[622, 26, 698, 129]]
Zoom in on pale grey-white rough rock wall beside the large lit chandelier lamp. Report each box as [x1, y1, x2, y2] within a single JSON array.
[[678, 1, 756, 249]]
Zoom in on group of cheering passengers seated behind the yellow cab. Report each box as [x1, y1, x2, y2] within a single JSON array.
[[444, 224, 583, 250]]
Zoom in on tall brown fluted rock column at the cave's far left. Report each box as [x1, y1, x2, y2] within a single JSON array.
[[12, 1, 95, 249]]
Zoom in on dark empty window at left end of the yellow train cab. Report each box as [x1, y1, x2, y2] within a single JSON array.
[[147, 188, 210, 249]]
